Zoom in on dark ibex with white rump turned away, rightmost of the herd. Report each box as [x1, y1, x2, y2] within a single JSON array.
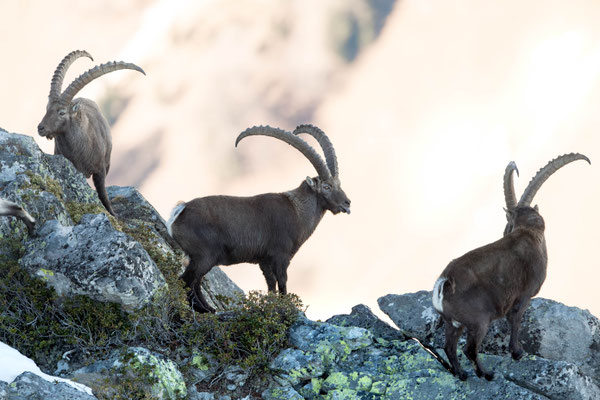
[[432, 154, 589, 380]]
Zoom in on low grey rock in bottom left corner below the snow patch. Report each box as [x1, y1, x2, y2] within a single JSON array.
[[0, 372, 96, 400]]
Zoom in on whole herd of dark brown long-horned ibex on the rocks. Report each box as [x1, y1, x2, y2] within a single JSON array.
[[0, 50, 590, 380]]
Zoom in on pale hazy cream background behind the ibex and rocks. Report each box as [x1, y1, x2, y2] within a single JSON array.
[[0, 0, 600, 319]]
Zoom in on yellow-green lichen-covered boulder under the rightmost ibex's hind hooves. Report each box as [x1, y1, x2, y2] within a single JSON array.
[[262, 318, 600, 400]]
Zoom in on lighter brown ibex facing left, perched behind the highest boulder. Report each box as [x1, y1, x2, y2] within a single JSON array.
[[38, 50, 145, 215]]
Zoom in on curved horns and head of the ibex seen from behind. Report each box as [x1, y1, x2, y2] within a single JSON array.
[[504, 153, 591, 236]]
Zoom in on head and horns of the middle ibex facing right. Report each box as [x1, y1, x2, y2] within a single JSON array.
[[235, 125, 350, 214]]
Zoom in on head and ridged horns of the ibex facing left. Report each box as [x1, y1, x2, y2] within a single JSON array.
[[38, 50, 145, 139]]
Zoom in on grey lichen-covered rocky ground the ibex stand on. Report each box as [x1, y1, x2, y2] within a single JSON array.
[[0, 130, 600, 400]]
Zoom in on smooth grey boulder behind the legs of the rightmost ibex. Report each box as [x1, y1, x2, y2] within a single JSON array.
[[378, 291, 600, 383]]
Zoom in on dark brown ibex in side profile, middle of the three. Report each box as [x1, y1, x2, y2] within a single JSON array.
[[167, 125, 350, 312]]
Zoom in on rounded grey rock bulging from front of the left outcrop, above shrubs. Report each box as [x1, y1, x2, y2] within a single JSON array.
[[20, 214, 166, 310]]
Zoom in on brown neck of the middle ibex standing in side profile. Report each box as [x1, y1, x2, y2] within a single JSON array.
[[284, 182, 326, 244]]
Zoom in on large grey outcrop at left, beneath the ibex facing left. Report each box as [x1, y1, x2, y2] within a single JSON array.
[[0, 130, 243, 310]]
